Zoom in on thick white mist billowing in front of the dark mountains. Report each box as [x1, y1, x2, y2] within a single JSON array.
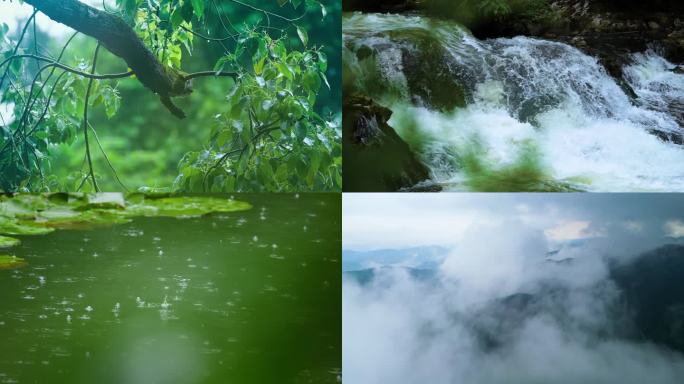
[[342, 216, 684, 384]]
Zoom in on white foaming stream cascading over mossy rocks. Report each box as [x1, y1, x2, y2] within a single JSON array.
[[343, 13, 684, 191]]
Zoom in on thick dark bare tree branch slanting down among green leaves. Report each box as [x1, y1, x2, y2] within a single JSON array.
[[25, 0, 190, 117]]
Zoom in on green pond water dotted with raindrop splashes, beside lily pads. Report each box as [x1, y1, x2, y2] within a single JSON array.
[[0, 194, 342, 384]]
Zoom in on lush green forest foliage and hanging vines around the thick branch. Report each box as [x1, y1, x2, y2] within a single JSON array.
[[0, 0, 341, 192]]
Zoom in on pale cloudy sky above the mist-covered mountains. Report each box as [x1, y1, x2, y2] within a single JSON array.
[[343, 193, 684, 251]]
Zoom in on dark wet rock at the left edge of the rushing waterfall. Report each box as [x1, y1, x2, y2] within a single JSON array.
[[342, 95, 430, 192]]
